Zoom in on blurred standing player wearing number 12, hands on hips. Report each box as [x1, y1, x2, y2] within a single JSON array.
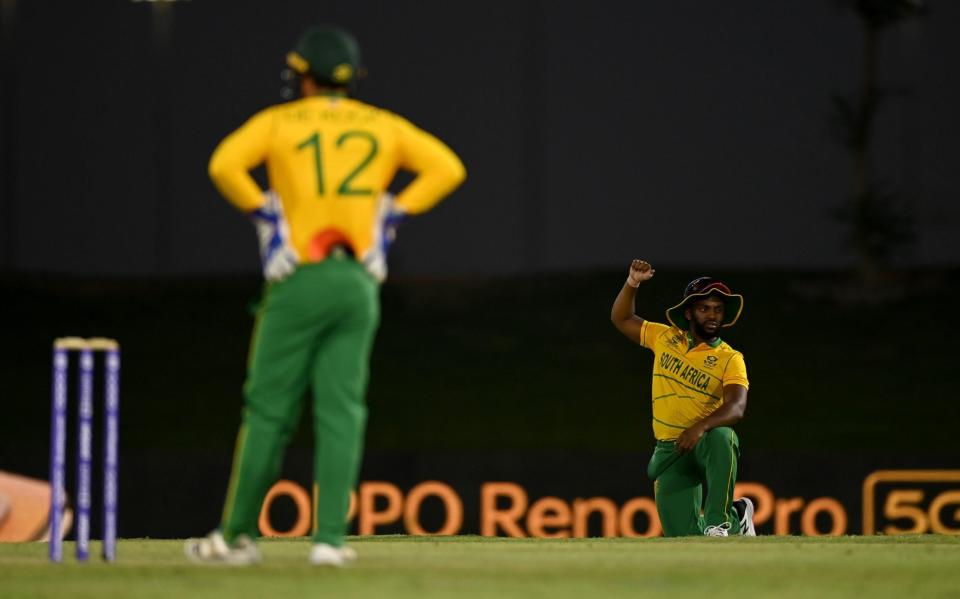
[[186, 27, 465, 566]]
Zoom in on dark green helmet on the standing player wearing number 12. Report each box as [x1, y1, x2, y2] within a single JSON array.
[[287, 25, 363, 87]]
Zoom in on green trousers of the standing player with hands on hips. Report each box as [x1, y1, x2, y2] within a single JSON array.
[[220, 253, 380, 547]]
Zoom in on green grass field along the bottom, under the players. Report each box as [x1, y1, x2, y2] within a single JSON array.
[[0, 536, 960, 599]]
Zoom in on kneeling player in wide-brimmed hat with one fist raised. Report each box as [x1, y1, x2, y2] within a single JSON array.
[[610, 260, 756, 537]]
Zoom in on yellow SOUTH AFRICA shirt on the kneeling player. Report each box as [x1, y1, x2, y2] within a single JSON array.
[[640, 320, 750, 441]]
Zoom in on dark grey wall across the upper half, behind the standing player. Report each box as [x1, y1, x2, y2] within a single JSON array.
[[0, 0, 960, 275]]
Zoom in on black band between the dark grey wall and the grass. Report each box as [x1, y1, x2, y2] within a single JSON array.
[[0, 269, 960, 537]]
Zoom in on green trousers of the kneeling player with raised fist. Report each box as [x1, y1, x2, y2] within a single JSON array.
[[647, 426, 740, 537]]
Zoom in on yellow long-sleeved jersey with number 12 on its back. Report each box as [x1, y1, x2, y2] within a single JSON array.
[[209, 96, 466, 260]]
